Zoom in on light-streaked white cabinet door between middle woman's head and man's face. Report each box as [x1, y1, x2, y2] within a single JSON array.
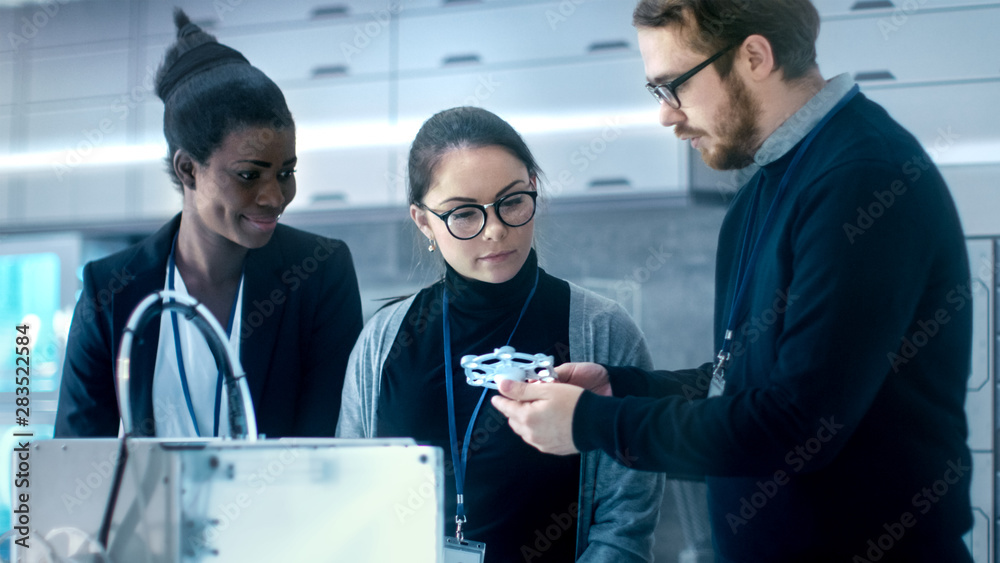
[[399, 55, 681, 195]]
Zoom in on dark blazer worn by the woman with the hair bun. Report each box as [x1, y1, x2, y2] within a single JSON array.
[[55, 214, 362, 438]]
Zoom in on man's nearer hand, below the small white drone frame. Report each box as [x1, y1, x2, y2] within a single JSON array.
[[491, 379, 583, 455]]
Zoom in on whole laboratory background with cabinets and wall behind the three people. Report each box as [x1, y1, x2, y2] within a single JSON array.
[[0, 0, 1000, 563]]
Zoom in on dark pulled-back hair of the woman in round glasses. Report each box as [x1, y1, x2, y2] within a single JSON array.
[[407, 106, 541, 204]]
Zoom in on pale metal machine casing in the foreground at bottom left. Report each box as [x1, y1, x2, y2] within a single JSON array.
[[15, 439, 444, 563]]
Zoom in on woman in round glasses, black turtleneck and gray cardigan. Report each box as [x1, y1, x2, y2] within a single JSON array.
[[337, 107, 663, 562]]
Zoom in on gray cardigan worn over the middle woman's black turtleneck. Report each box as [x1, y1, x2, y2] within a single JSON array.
[[337, 283, 665, 562]]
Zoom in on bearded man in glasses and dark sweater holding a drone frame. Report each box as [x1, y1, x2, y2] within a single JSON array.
[[493, 0, 972, 563]]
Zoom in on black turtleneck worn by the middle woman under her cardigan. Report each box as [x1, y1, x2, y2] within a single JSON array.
[[377, 250, 580, 562]]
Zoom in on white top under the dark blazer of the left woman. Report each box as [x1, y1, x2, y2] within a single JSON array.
[[153, 263, 243, 438]]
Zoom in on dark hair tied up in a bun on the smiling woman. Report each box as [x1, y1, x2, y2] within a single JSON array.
[[156, 9, 295, 188]]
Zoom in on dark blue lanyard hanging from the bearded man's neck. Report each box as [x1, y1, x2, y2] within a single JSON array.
[[708, 84, 860, 397]]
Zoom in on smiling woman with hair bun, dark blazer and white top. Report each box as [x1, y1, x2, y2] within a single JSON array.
[[55, 10, 362, 438]]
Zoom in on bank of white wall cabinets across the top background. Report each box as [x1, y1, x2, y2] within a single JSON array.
[[0, 0, 1000, 227]]
